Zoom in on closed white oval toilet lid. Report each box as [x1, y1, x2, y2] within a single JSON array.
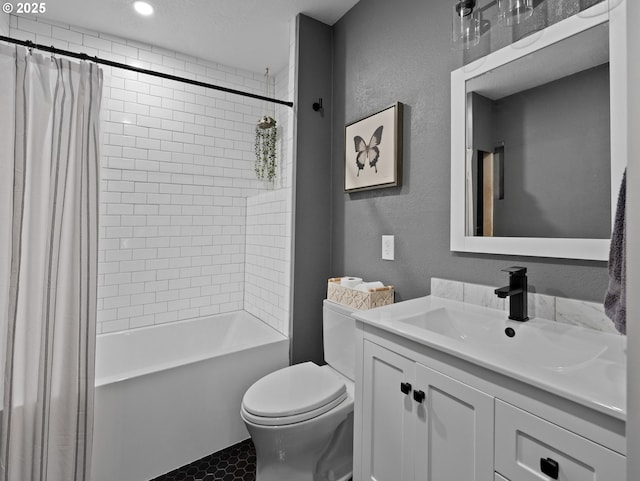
[[242, 362, 347, 420]]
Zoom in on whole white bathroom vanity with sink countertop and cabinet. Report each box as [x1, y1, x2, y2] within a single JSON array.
[[353, 296, 626, 481]]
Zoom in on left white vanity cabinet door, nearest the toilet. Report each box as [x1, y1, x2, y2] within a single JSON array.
[[362, 341, 415, 481]]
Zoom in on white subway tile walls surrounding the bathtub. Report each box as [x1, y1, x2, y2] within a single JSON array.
[[9, 15, 292, 334]]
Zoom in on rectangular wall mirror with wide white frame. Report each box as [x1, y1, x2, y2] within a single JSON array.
[[451, 2, 625, 260]]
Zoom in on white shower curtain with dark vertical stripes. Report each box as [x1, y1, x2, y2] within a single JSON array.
[[0, 45, 102, 481]]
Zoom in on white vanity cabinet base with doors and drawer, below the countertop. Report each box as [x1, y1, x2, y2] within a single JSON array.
[[353, 321, 625, 481]]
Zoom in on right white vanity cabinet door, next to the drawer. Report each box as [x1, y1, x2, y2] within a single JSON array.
[[415, 364, 495, 481]]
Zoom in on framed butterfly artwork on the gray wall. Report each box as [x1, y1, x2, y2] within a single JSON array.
[[344, 102, 402, 192]]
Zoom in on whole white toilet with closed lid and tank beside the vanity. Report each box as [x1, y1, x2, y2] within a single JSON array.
[[240, 300, 355, 481]]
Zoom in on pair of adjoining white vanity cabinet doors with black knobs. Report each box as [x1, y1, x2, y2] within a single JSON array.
[[355, 340, 494, 481]]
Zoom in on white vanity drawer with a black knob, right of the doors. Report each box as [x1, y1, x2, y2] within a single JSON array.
[[495, 399, 626, 481]]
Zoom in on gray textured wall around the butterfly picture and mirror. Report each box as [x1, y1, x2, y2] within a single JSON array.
[[331, 0, 607, 302]]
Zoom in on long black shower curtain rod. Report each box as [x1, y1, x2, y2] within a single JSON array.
[[0, 35, 293, 107]]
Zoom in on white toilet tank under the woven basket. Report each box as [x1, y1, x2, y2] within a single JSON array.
[[322, 299, 356, 380]]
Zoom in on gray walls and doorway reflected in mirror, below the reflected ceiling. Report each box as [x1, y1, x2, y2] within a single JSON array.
[[467, 63, 611, 239]]
